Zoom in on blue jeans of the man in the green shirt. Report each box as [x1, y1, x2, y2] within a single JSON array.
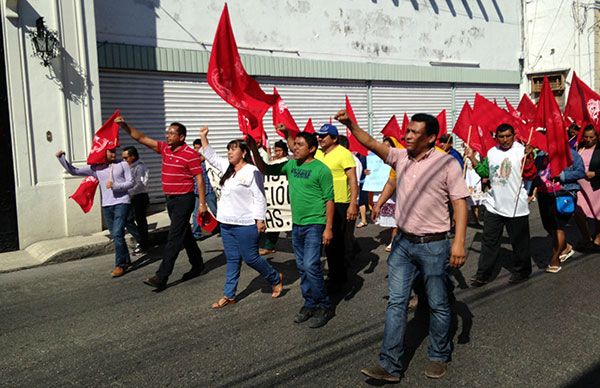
[[292, 224, 331, 310]]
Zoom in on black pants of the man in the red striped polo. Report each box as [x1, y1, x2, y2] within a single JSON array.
[[156, 193, 203, 282]]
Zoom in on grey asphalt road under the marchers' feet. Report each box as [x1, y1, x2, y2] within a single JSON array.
[[0, 211, 600, 387]]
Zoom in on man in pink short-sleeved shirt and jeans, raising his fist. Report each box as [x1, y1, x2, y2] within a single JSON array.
[[336, 110, 469, 382]]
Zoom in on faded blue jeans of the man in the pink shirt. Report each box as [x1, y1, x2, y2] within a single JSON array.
[[379, 232, 452, 376]]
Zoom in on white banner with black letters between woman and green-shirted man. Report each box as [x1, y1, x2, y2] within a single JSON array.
[[265, 175, 292, 232]]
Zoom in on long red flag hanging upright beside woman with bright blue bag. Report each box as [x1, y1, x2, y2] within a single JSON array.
[[535, 77, 573, 176]]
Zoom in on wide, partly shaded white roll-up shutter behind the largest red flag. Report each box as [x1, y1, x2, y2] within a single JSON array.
[[100, 70, 367, 203]]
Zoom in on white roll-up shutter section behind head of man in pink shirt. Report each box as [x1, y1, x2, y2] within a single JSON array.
[[372, 82, 453, 138]]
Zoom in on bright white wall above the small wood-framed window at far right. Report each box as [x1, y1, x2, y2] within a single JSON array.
[[523, 0, 596, 91]]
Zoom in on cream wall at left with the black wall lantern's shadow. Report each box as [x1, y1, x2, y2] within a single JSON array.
[[1, 0, 101, 249]]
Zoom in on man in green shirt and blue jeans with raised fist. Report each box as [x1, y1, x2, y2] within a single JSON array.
[[248, 129, 334, 328]]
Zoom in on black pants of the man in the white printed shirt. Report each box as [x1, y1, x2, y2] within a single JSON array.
[[476, 211, 531, 280]]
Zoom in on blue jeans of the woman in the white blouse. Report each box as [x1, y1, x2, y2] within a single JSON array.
[[221, 224, 279, 298]]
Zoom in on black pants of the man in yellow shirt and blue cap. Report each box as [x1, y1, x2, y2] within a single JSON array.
[[325, 203, 356, 283]]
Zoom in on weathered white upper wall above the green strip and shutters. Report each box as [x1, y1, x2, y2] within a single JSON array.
[[94, 0, 520, 70]]
